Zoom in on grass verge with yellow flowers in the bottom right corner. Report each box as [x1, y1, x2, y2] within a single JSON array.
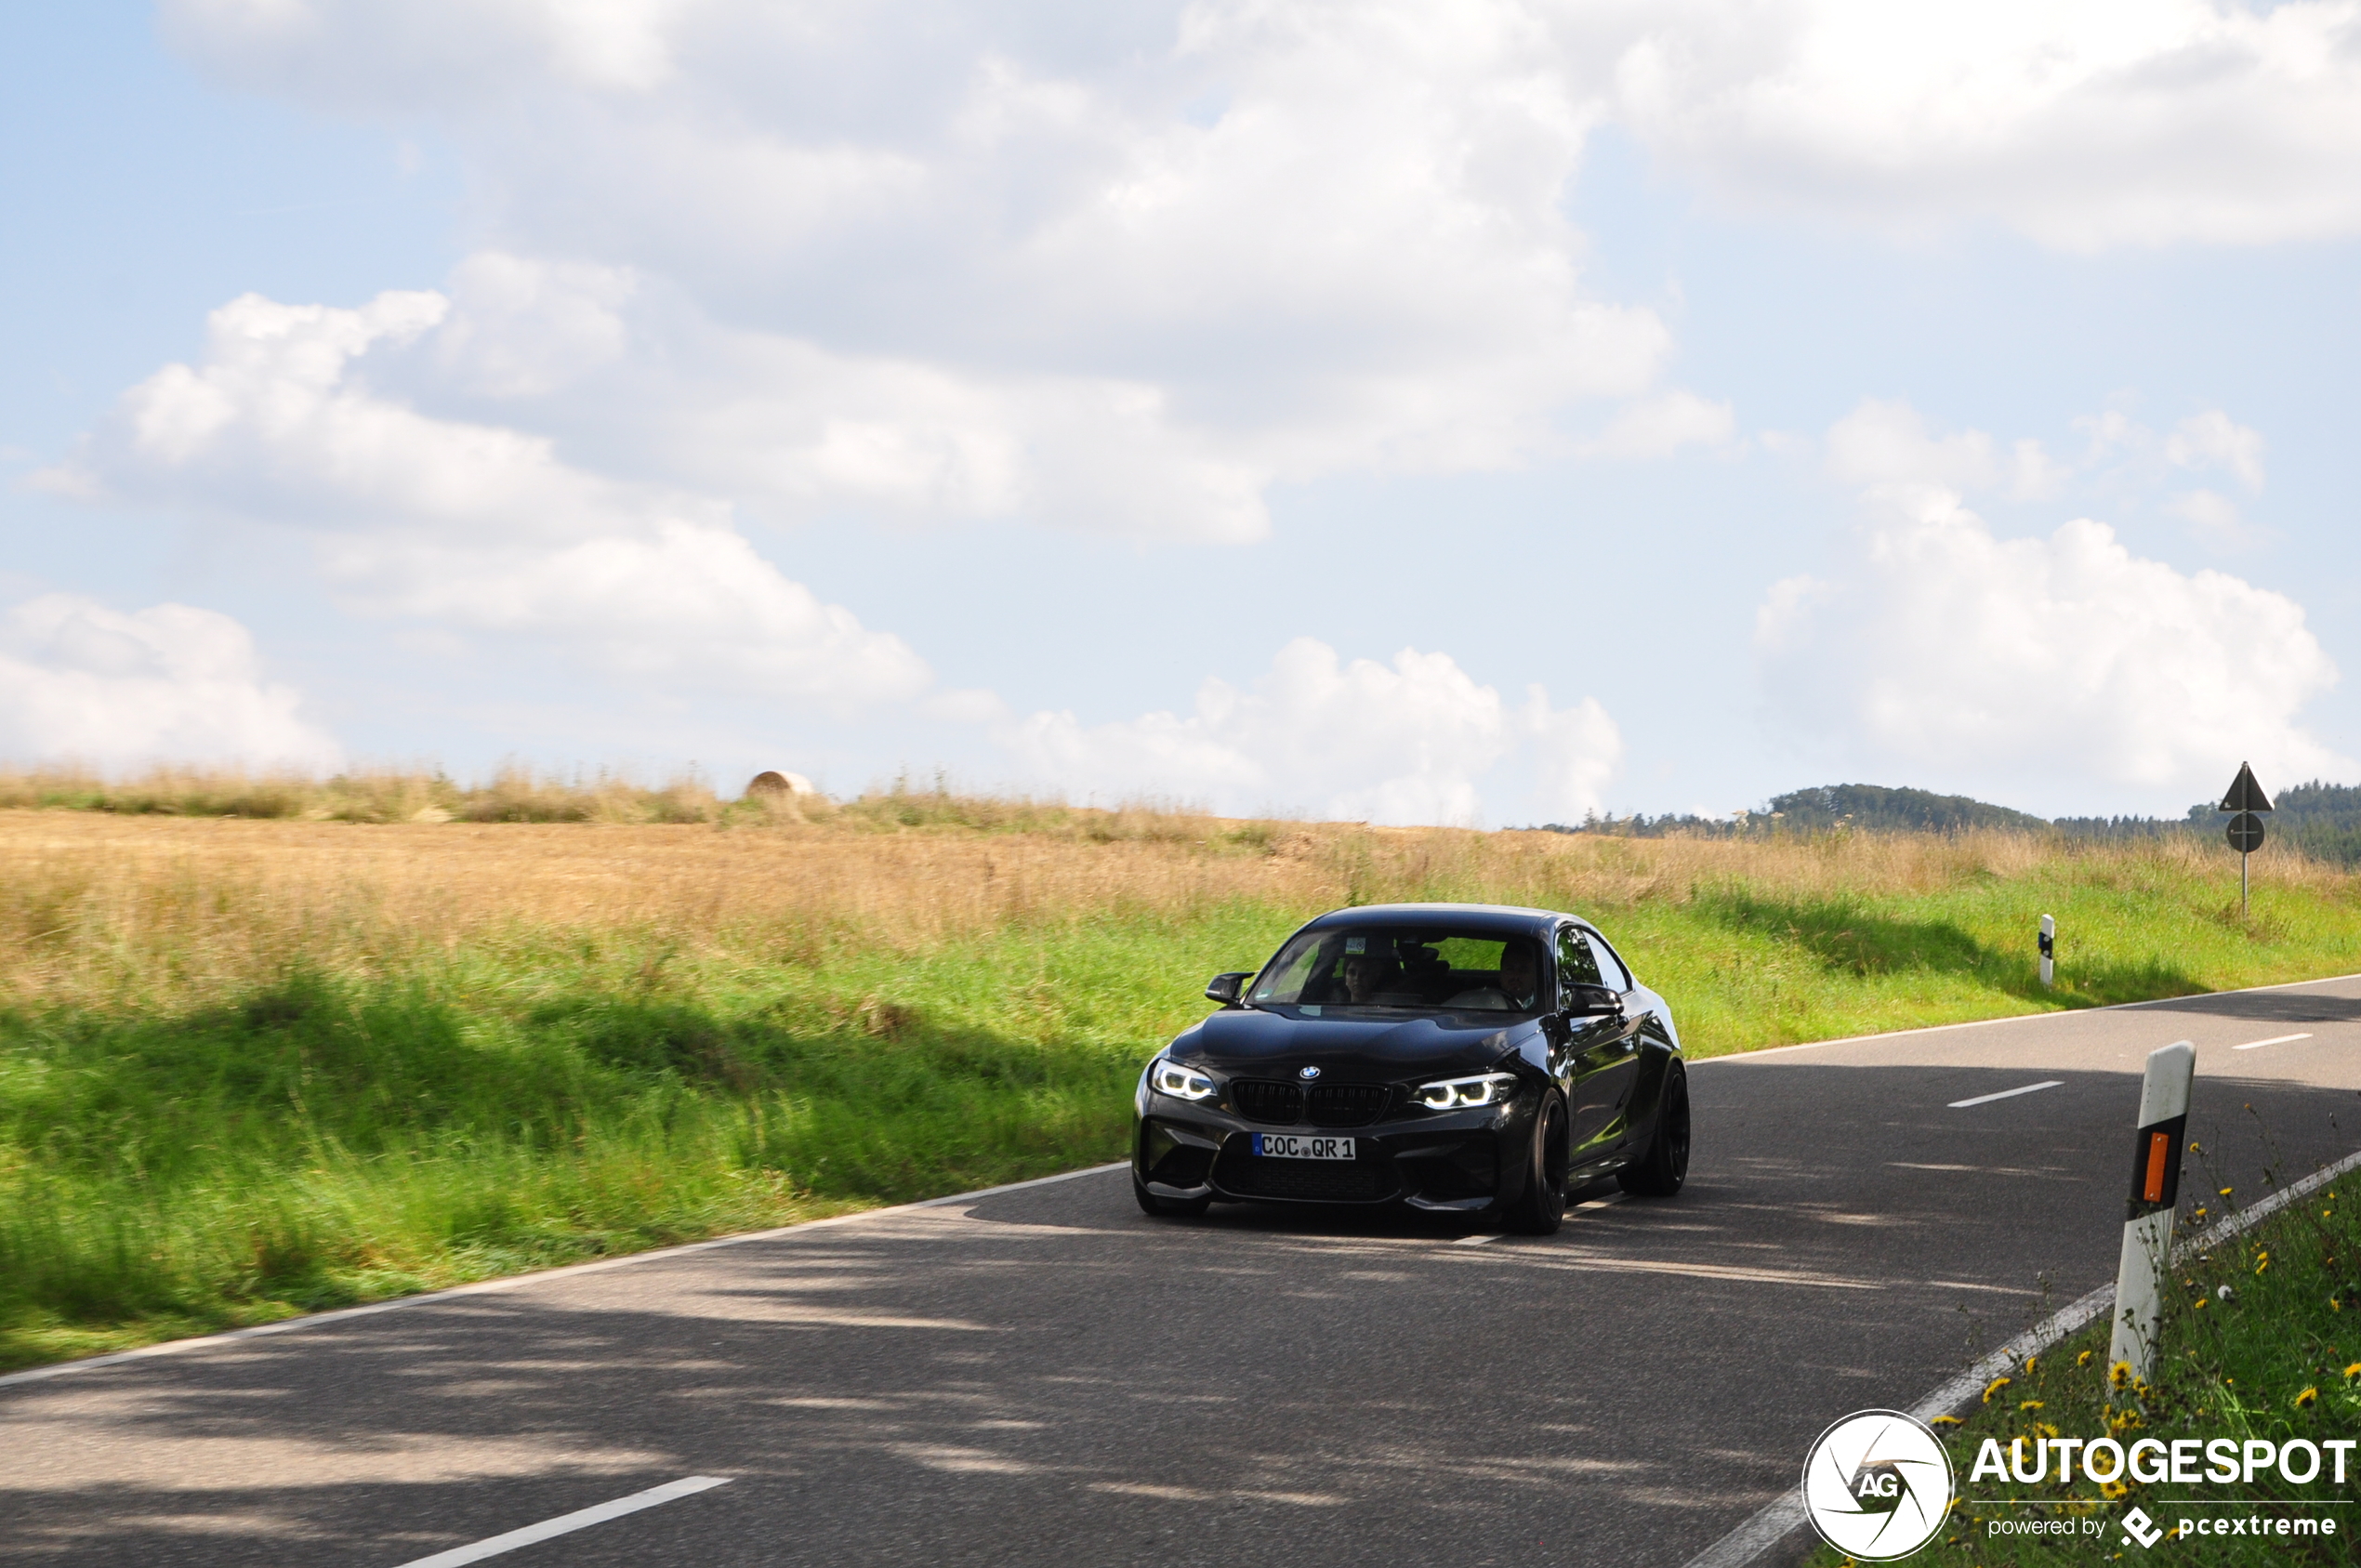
[[1811, 1156, 2361, 1568]]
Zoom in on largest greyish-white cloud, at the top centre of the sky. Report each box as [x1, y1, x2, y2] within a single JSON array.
[[152, 0, 1697, 541]]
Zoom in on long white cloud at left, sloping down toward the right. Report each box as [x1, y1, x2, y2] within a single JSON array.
[[43, 287, 930, 708]]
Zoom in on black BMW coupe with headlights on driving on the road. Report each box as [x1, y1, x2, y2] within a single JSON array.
[[1131, 904, 1688, 1235]]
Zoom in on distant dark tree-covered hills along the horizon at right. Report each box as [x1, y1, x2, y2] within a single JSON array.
[[1544, 779, 2361, 866]]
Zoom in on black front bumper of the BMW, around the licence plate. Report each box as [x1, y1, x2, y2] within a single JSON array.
[[1131, 1091, 1532, 1214]]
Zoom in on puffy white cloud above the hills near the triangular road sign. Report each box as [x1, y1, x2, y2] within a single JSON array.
[[1757, 491, 2354, 808]]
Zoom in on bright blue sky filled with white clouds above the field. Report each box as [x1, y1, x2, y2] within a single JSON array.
[[0, 0, 2361, 826]]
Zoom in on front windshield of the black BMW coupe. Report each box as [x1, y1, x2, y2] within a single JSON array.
[[1246, 926, 1542, 1013]]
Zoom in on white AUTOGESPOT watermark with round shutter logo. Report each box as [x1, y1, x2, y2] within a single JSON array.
[[1804, 1410, 2361, 1563]]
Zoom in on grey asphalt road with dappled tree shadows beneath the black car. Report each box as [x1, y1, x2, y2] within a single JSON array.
[[0, 980, 2361, 1568]]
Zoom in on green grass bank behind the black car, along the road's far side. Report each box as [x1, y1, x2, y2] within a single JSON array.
[[0, 824, 2361, 1365]]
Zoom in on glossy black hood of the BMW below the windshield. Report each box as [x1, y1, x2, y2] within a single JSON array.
[[1168, 1008, 1535, 1079]]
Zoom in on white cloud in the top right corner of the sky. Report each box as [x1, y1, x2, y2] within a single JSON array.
[[1615, 0, 2361, 250]]
